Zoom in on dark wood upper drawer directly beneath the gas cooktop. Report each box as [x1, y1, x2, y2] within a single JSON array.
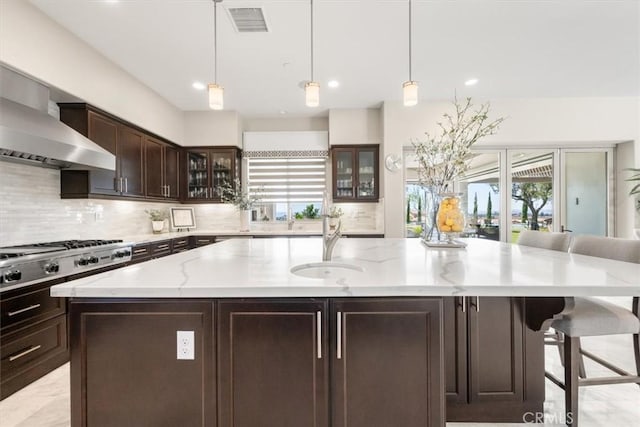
[[0, 280, 66, 333]]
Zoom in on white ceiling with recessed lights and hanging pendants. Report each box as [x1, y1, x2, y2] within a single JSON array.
[[30, 0, 640, 117]]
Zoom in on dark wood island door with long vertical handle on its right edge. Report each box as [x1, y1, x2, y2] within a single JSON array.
[[218, 299, 329, 427]]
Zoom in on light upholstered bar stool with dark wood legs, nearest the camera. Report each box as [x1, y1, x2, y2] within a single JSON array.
[[545, 236, 640, 427]]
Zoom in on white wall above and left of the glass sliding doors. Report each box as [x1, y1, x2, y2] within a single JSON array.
[[382, 98, 640, 237]]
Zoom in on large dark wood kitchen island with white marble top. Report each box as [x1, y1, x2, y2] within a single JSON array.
[[52, 238, 640, 427]]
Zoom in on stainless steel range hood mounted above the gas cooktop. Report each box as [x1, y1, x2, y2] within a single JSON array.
[[0, 67, 116, 170]]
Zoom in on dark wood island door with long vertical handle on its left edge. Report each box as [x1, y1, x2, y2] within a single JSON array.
[[330, 298, 445, 427]]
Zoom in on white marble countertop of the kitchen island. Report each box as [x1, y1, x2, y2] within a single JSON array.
[[51, 238, 640, 298]]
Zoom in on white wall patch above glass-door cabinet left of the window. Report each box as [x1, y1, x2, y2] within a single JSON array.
[[182, 111, 242, 147]]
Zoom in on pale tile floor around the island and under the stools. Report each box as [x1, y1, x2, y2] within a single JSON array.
[[0, 336, 640, 427]]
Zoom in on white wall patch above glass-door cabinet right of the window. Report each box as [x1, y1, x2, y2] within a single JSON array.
[[329, 108, 383, 145]]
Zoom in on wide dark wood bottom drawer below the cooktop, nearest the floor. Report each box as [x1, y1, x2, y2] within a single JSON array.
[[0, 315, 69, 399]]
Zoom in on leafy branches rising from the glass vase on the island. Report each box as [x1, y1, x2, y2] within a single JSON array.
[[412, 97, 504, 194]]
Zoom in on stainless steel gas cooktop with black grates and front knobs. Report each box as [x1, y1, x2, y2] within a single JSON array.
[[0, 239, 133, 290]]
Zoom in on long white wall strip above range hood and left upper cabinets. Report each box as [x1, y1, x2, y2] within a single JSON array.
[[0, 0, 183, 144]]
